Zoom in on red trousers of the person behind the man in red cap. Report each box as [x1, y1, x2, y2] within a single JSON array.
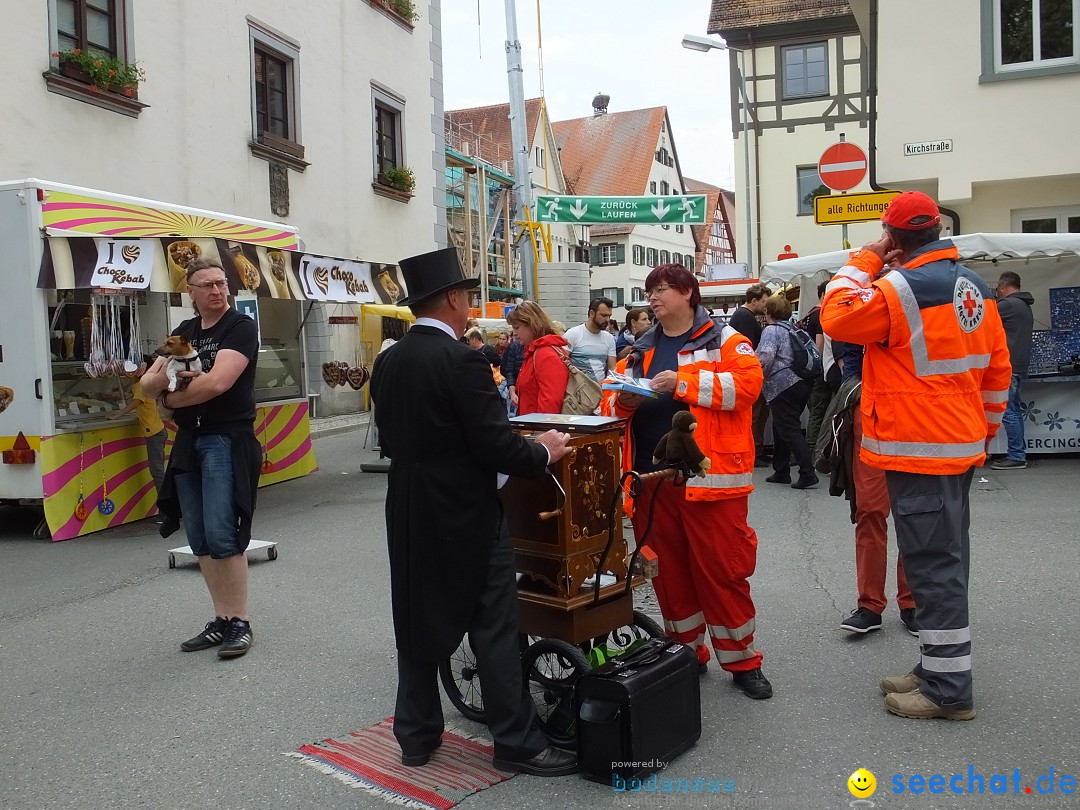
[[852, 406, 915, 613]]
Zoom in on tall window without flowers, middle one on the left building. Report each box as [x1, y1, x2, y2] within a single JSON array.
[[247, 17, 303, 151]]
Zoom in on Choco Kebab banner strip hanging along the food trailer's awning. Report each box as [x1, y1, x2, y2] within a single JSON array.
[[38, 235, 407, 306]]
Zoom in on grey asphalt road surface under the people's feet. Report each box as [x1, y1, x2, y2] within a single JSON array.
[[0, 431, 1080, 810]]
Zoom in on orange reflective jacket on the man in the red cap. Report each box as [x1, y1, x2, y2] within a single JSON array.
[[821, 240, 1012, 475]]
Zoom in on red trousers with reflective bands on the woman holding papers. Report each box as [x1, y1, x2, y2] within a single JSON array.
[[633, 481, 761, 672]]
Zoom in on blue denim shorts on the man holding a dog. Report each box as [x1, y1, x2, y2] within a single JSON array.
[[176, 435, 243, 559]]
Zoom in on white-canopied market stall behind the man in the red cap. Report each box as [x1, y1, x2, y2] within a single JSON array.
[[761, 233, 1080, 455]]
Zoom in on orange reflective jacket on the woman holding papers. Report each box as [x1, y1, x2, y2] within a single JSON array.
[[600, 307, 762, 513]]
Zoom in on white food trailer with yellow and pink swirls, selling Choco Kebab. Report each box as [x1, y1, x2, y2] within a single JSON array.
[[0, 179, 406, 540]]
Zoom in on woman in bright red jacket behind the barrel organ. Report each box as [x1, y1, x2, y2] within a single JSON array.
[[507, 301, 570, 416]]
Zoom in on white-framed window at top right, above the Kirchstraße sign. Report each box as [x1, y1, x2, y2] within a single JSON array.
[[984, 0, 1080, 72]]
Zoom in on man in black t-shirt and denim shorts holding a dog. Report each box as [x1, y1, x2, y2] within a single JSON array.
[[143, 259, 261, 658]]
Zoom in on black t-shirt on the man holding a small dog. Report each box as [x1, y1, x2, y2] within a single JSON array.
[[173, 309, 259, 435]]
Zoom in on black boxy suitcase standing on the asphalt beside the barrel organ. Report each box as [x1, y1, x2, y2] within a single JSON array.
[[573, 638, 701, 784]]
